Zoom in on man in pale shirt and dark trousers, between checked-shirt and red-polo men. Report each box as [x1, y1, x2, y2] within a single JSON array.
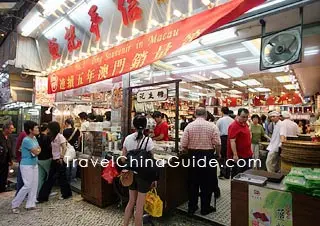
[[217, 107, 234, 179]]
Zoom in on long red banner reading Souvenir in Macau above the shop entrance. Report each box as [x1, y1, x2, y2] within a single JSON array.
[[48, 0, 264, 93]]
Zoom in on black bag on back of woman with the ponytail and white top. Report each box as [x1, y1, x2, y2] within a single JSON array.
[[125, 137, 159, 182]]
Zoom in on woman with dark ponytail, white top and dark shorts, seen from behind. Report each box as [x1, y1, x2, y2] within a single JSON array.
[[122, 115, 153, 226]]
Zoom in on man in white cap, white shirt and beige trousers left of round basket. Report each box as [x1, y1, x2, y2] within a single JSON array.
[[266, 111, 284, 173]]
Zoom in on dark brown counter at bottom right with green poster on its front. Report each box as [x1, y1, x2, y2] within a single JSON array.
[[231, 170, 320, 226]]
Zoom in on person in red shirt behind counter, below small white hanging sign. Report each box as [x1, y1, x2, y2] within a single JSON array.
[[152, 111, 169, 141]]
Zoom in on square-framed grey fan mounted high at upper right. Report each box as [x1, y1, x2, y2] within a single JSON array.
[[260, 25, 302, 70]]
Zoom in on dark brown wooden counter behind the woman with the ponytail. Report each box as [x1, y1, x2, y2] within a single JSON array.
[[81, 149, 188, 214]]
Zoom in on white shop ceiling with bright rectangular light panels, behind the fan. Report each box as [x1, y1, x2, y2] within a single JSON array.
[[131, 2, 320, 96]]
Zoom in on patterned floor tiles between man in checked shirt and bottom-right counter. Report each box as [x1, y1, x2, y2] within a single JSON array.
[[178, 179, 231, 226]]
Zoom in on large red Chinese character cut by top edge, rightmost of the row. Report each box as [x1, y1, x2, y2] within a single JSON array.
[[118, 0, 142, 26]]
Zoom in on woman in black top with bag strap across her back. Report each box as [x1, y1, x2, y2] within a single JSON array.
[[63, 118, 81, 183]]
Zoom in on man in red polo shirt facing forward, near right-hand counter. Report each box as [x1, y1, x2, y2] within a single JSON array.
[[227, 108, 253, 178]]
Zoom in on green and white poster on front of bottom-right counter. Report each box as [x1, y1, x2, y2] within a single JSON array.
[[248, 185, 293, 226]]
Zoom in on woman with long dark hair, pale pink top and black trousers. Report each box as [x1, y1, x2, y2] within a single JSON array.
[[38, 122, 72, 202]]
